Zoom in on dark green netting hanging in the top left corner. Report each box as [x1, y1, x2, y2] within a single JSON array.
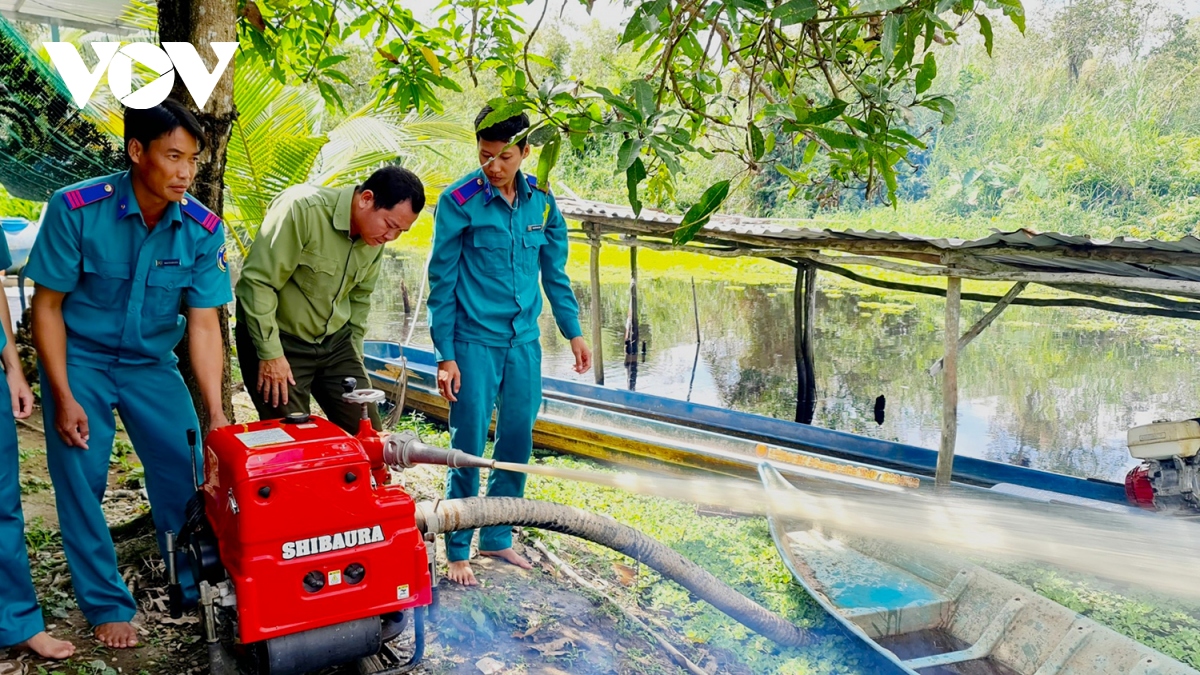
[[0, 18, 125, 202]]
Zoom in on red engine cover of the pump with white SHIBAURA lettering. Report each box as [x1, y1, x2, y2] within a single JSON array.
[[202, 417, 432, 644]]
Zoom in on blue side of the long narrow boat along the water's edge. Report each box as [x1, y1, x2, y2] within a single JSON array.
[[364, 340, 1126, 504]]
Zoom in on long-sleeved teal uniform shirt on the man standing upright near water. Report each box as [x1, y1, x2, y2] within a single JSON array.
[[428, 169, 583, 362]]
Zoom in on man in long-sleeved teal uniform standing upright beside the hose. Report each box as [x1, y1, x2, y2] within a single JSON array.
[[428, 108, 592, 585]]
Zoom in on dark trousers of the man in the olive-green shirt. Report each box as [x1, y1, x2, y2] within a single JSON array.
[[234, 299, 383, 434]]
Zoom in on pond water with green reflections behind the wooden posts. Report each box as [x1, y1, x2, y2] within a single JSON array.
[[368, 249, 1200, 479]]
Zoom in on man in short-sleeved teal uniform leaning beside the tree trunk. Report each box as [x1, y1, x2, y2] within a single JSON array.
[[26, 100, 233, 647]]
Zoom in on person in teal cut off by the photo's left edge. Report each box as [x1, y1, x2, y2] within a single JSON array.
[[0, 228, 74, 658]]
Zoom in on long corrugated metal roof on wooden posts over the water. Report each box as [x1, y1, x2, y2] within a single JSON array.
[[558, 198, 1200, 289]]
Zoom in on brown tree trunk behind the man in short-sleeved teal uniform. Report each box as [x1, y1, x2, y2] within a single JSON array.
[[158, 0, 238, 429]]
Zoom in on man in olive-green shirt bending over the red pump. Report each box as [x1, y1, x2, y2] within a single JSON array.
[[235, 166, 425, 434]]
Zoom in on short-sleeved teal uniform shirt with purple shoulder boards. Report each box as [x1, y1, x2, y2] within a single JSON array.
[[25, 172, 233, 368]]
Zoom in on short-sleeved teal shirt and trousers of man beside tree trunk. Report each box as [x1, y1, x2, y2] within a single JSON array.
[[25, 172, 233, 626]]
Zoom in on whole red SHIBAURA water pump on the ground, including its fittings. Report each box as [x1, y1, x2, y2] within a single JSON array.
[[167, 378, 492, 675]]
